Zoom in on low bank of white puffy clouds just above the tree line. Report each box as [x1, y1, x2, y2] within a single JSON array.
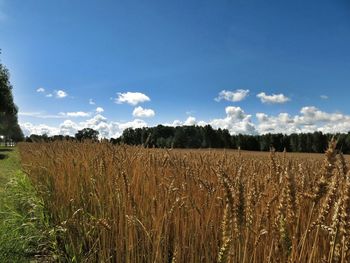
[[19, 106, 350, 138]]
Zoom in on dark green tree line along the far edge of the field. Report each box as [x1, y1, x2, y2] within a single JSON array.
[[26, 125, 350, 154]]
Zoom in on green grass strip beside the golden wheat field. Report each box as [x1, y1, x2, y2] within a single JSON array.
[[0, 147, 52, 262]]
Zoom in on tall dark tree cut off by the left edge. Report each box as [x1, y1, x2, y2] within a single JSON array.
[[0, 58, 24, 141]]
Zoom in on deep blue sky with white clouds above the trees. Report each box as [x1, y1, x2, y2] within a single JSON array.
[[0, 0, 350, 137]]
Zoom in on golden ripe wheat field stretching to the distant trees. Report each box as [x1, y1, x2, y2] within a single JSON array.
[[19, 141, 350, 262]]
